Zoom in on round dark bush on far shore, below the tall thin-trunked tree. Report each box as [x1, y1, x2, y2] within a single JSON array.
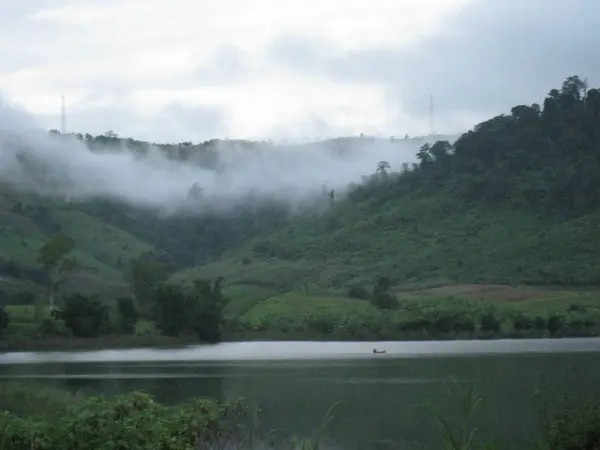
[[55, 293, 109, 338]]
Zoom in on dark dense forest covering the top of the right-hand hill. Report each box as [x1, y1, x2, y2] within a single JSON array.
[[358, 76, 600, 218]]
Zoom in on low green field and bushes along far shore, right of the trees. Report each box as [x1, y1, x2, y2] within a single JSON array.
[[228, 293, 600, 340]]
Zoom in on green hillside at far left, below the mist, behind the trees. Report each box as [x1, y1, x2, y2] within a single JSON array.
[[0, 187, 152, 299]]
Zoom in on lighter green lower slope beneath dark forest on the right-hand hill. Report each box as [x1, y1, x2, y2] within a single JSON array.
[[181, 192, 600, 291]]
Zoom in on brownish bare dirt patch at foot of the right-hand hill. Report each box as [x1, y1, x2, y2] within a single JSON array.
[[399, 284, 548, 302]]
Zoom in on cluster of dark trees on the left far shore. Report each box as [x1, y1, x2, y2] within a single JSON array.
[[0, 233, 227, 342]]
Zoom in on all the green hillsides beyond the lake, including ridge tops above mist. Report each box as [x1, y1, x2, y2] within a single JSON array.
[[0, 77, 600, 310]]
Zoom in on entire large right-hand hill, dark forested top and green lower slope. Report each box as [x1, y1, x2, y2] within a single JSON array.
[[184, 77, 600, 290]]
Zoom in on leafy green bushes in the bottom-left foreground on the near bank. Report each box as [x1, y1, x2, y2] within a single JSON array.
[[0, 392, 329, 450]]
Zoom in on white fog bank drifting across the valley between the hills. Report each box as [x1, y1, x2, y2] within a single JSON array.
[[0, 99, 460, 215]]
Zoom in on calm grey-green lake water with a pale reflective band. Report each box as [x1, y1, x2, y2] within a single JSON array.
[[0, 338, 600, 450]]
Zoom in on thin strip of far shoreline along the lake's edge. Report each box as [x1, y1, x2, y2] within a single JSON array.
[[0, 330, 600, 353]]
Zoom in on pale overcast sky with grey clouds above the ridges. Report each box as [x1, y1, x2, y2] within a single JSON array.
[[0, 0, 600, 142]]
